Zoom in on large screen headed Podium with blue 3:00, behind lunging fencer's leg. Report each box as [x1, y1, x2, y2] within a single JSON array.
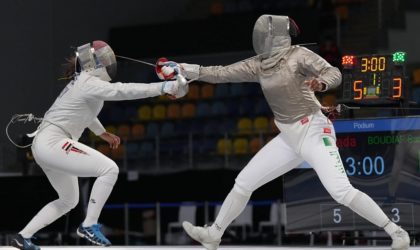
[[284, 117, 420, 233]]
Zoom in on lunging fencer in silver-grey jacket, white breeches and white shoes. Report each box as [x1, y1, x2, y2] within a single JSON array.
[[165, 15, 410, 250]]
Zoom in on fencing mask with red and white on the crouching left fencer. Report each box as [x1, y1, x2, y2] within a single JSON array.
[[76, 40, 117, 81]]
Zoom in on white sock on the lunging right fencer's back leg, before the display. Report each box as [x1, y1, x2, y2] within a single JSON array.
[[348, 190, 389, 228]]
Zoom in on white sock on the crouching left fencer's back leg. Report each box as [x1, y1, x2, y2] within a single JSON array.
[[19, 199, 72, 239]]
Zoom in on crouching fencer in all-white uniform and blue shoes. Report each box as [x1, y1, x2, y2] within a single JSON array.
[[11, 41, 188, 250]]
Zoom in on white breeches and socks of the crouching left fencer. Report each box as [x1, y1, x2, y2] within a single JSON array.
[[20, 124, 119, 238]]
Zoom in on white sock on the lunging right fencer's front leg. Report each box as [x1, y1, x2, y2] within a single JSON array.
[[209, 185, 251, 239]]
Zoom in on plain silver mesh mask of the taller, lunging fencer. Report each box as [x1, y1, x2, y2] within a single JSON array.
[[252, 15, 300, 58]]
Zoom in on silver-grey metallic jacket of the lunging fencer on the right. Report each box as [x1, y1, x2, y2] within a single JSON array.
[[194, 46, 341, 124]]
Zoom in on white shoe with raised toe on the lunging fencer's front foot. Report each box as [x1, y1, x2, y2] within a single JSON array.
[[182, 221, 221, 250]]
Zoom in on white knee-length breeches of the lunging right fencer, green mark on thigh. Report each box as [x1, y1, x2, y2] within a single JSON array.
[[236, 111, 353, 203]]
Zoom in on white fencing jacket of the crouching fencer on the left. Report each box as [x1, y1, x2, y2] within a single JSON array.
[[40, 72, 163, 140]]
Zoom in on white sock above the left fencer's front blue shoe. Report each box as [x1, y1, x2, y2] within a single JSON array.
[[82, 178, 114, 227]]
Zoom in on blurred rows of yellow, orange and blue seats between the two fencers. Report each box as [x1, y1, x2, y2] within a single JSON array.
[[89, 82, 277, 164]]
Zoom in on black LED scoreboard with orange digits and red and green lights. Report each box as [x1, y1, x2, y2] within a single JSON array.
[[341, 52, 407, 104]]
